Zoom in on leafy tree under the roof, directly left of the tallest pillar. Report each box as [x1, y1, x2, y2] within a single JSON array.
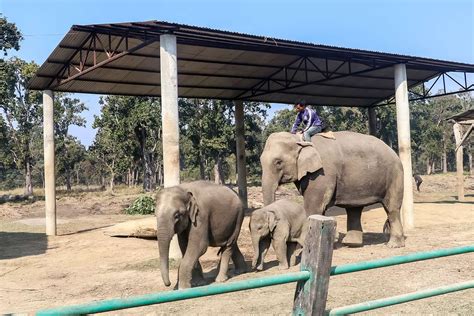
[[93, 96, 162, 191]]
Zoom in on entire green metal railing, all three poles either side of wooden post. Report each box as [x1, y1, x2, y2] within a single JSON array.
[[37, 245, 474, 315]]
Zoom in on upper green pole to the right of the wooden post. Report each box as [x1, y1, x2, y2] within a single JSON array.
[[331, 245, 474, 275]]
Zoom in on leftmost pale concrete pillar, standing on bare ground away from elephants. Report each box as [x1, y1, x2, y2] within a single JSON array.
[[43, 90, 57, 236]]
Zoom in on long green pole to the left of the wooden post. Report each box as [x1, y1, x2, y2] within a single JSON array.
[[36, 271, 311, 315]]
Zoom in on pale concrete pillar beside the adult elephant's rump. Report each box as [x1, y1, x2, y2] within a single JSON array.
[[394, 64, 414, 230]]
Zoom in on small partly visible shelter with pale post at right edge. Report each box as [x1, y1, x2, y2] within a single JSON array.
[[448, 109, 474, 202]]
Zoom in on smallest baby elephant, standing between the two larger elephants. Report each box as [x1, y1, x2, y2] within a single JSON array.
[[250, 200, 307, 270]]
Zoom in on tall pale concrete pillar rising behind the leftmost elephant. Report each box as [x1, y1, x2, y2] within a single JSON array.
[[160, 34, 181, 259]]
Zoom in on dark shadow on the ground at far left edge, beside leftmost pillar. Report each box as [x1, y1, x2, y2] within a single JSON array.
[[0, 232, 48, 260]]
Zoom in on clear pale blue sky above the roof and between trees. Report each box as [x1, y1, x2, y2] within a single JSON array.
[[0, 0, 474, 146]]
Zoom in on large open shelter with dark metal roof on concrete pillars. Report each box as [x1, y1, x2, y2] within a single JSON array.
[[30, 21, 474, 235]]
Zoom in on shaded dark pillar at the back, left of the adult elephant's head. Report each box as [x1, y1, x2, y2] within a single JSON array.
[[234, 101, 248, 208]]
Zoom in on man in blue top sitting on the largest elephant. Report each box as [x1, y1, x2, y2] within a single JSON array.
[[291, 100, 323, 142]]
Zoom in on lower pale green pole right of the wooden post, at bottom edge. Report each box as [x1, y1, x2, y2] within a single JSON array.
[[329, 280, 474, 315]]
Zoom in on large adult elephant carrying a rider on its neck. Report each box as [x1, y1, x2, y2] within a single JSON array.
[[260, 132, 405, 248]]
